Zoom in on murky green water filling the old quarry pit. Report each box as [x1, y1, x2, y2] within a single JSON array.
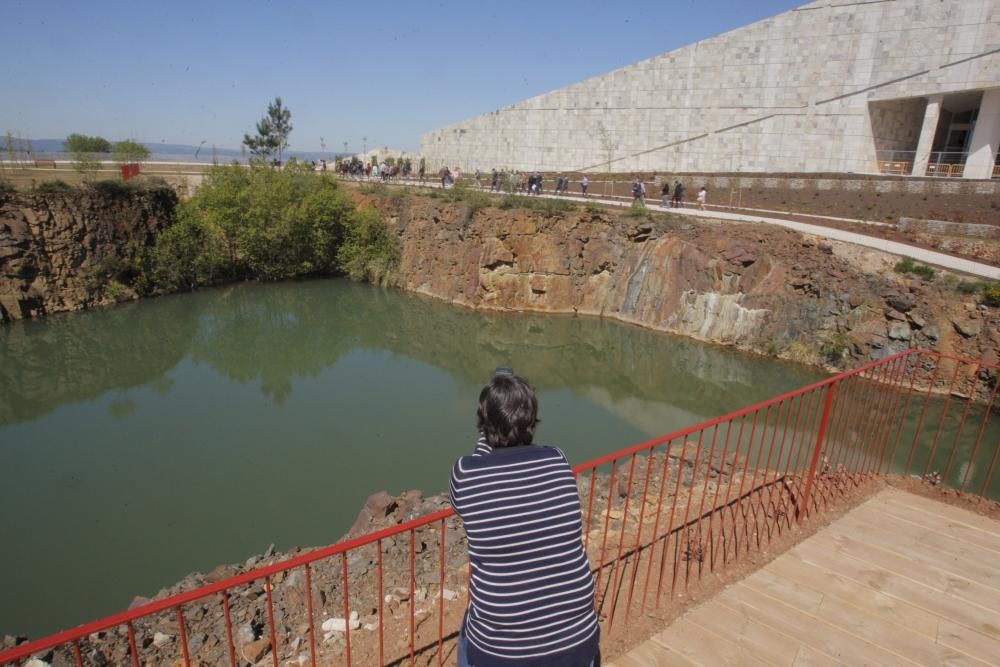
[[0, 280, 992, 636]]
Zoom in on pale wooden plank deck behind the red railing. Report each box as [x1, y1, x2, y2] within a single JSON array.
[[612, 489, 1000, 667]]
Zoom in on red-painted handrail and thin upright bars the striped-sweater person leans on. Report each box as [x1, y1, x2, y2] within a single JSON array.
[[0, 349, 1000, 665]]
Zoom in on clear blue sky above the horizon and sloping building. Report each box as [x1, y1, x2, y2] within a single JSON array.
[[0, 0, 806, 151]]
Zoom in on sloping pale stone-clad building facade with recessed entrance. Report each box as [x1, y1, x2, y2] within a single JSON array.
[[420, 0, 1000, 178]]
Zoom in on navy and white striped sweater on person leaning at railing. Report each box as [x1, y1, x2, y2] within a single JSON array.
[[450, 438, 600, 667]]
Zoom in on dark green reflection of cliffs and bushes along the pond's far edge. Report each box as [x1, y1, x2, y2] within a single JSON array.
[[0, 282, 818, 424]]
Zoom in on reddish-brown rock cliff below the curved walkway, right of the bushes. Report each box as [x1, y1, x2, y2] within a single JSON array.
[[385, 198, 1000, 376]]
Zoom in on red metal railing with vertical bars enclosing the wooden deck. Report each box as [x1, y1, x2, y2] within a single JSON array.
[[0, 350, 1000, 667]]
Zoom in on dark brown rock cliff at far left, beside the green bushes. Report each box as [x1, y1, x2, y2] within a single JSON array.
[[0, 188, 177, 321]]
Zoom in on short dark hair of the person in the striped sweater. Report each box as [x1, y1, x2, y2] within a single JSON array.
[[476, 375, 538, 449]]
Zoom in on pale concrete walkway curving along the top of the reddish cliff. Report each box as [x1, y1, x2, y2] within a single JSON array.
[[384, 181, 1000, 280]]
